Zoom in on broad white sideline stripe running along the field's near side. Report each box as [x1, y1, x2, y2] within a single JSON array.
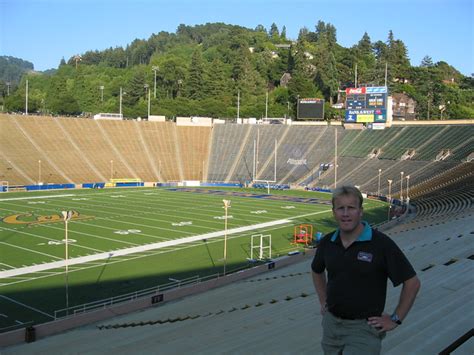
[[0, 219, 290, 279]]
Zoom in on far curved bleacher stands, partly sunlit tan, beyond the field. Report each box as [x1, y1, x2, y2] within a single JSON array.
[[0, 115, 474, 197]]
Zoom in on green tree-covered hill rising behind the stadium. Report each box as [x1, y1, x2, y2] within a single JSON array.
[[0, 21, 474, 119]]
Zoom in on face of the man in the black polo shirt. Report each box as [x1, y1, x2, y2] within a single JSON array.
[[332, 195, 363, 234]]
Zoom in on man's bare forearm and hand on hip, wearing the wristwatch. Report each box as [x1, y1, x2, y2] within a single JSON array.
[[368, 275, 421, 331]]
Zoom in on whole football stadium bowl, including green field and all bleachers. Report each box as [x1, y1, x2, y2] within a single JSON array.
[[0, 114, 474, 354]]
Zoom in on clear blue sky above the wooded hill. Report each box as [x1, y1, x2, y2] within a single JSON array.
[[0, 0, 474, 76]]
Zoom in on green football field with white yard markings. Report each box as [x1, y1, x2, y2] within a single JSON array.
[[0, 187, 387, 332]]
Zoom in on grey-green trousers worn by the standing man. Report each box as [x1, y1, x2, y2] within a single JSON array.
[[321, 312, 385, 355]]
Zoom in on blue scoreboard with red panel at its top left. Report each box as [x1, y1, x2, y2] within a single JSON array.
[[345, 86, 388, 123]]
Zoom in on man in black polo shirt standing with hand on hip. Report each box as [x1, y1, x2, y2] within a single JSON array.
[[311, 186, 420, 354]]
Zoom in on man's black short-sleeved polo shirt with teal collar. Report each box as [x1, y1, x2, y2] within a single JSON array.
[[311, 222, 416, 319]]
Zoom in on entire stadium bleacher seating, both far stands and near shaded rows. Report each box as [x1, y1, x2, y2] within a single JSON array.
[[0, 115, 474, 354]]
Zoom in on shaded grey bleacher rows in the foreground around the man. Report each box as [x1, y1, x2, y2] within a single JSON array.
[[2, 204, 474, 355]]
